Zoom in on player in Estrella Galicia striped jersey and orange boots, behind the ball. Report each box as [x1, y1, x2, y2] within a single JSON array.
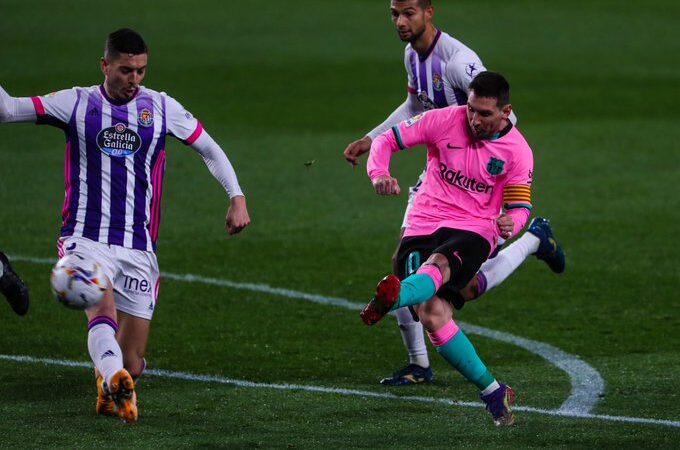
[[0, 28, 250, 422]]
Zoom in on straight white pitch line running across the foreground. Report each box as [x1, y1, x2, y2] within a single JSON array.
[[0, 355, 680, 428]]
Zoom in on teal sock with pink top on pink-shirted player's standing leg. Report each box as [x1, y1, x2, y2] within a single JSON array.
[[427, 320, 495, 391]]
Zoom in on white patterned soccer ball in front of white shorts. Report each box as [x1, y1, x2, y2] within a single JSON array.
[[50, 254, 106, 309]]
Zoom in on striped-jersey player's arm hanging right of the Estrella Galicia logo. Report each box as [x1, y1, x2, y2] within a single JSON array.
[[167, 97, 250, 234]]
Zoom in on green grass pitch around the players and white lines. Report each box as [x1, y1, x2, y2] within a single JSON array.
[[0, 0, 680, 448]]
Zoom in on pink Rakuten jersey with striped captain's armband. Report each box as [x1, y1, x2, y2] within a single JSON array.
[[366, 106, 533, 249]]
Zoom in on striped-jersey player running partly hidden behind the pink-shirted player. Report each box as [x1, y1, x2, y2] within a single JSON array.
[[344, 0, 565, 386]]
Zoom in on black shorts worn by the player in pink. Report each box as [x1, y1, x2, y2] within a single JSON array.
[[397, 228, 490, 294]]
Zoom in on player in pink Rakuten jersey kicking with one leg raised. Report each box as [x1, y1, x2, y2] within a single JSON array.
[[361, 72, 533, 426]]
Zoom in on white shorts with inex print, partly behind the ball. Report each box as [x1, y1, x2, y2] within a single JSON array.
[[57, 236, 160, 320]]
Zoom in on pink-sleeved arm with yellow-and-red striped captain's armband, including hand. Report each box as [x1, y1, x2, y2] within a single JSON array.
[[498, 146, 534, 239]]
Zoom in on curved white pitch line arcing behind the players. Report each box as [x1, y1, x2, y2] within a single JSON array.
[[13, 256, 604, 414]]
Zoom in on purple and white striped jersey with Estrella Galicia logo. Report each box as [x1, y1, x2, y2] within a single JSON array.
[[31, 85, 203, 252]]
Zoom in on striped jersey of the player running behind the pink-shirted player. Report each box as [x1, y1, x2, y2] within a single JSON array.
[[404, 30, 486, 111]]
